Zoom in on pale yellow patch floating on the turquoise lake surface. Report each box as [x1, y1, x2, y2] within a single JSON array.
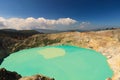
[[39, 48, 65, 59]]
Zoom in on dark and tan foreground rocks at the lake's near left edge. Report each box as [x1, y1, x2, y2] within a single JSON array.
[[0, 68, 55, 80]]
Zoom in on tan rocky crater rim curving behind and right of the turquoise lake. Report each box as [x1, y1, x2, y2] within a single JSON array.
[[0, 29, 120, 80]]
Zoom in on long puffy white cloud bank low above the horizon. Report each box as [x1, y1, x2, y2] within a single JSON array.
[[0, 17, 90, 30]]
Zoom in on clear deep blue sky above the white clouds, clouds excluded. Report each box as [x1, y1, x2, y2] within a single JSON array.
[[0, 0, 120, 29]]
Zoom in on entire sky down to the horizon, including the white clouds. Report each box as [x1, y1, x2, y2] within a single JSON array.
[[0, 0, 120, 30]]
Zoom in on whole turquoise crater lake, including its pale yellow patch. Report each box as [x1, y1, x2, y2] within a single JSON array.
[[0, 46, 113, 80]]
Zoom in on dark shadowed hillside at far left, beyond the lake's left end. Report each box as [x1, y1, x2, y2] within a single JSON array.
[[0, 29, 40, 63]]
